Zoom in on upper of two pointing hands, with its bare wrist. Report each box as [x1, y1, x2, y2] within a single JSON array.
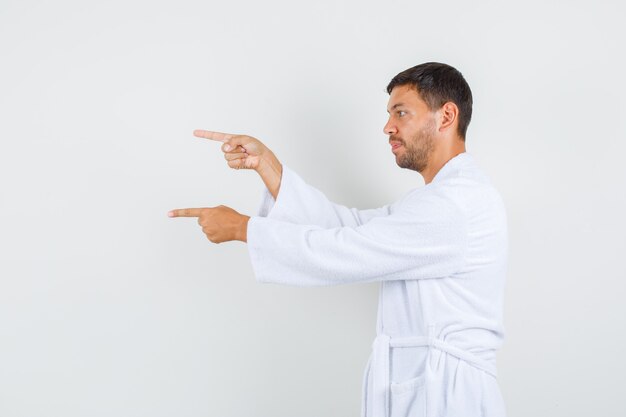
[[193, 130, 283, 198]]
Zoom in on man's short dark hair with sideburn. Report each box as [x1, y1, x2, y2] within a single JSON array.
[[387, 62, 472, 140]]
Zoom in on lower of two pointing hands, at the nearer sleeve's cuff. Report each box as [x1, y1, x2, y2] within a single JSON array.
[[167, 206, 250, 243]]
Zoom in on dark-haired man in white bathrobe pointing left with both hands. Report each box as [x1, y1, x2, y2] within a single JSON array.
[[170, 62, 507, 417]]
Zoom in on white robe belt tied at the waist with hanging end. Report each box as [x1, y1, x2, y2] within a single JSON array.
[[368, 334, 497, 417]]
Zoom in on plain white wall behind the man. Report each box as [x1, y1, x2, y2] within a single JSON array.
[[0, 0, 626, 417]]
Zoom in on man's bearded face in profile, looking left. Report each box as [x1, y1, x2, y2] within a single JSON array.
[[384, 86, 436, 172]]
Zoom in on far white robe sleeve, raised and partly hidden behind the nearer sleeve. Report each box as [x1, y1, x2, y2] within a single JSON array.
[[257, 164, 392, 228]]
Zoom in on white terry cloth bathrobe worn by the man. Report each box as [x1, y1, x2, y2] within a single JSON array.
[[247, 152, 507, 417]]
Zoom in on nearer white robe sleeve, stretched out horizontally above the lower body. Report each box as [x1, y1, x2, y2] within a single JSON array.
[[247, 193, 467, 287]]
